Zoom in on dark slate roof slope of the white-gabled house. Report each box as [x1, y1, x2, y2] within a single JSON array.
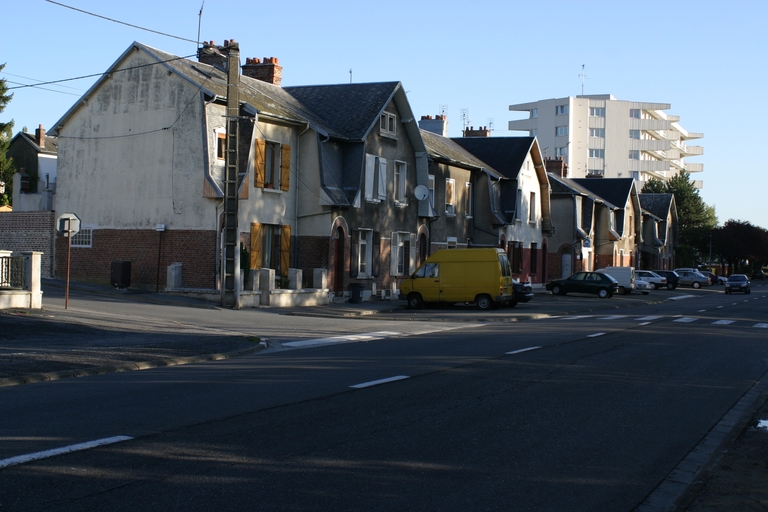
[[451, 137, 535, 179]]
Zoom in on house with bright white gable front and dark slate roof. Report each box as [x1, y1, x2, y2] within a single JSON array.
[[453, 136, 554, 284]]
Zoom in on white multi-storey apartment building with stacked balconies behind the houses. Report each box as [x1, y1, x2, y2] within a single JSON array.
[[509, 94, 704, 188]]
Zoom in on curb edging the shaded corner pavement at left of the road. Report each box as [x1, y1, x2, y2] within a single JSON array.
[[0, 346, 264, 388]]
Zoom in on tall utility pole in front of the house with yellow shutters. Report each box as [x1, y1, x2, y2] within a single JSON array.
[[221, 40, 240, 309]]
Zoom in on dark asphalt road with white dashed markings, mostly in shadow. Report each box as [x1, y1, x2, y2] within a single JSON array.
[[0, 282, 768, 511]]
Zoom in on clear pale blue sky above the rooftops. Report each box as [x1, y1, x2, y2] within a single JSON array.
[[0, 0, 768, 229]]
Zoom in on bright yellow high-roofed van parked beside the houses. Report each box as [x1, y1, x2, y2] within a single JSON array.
[[399, 248, 517, 309]]
